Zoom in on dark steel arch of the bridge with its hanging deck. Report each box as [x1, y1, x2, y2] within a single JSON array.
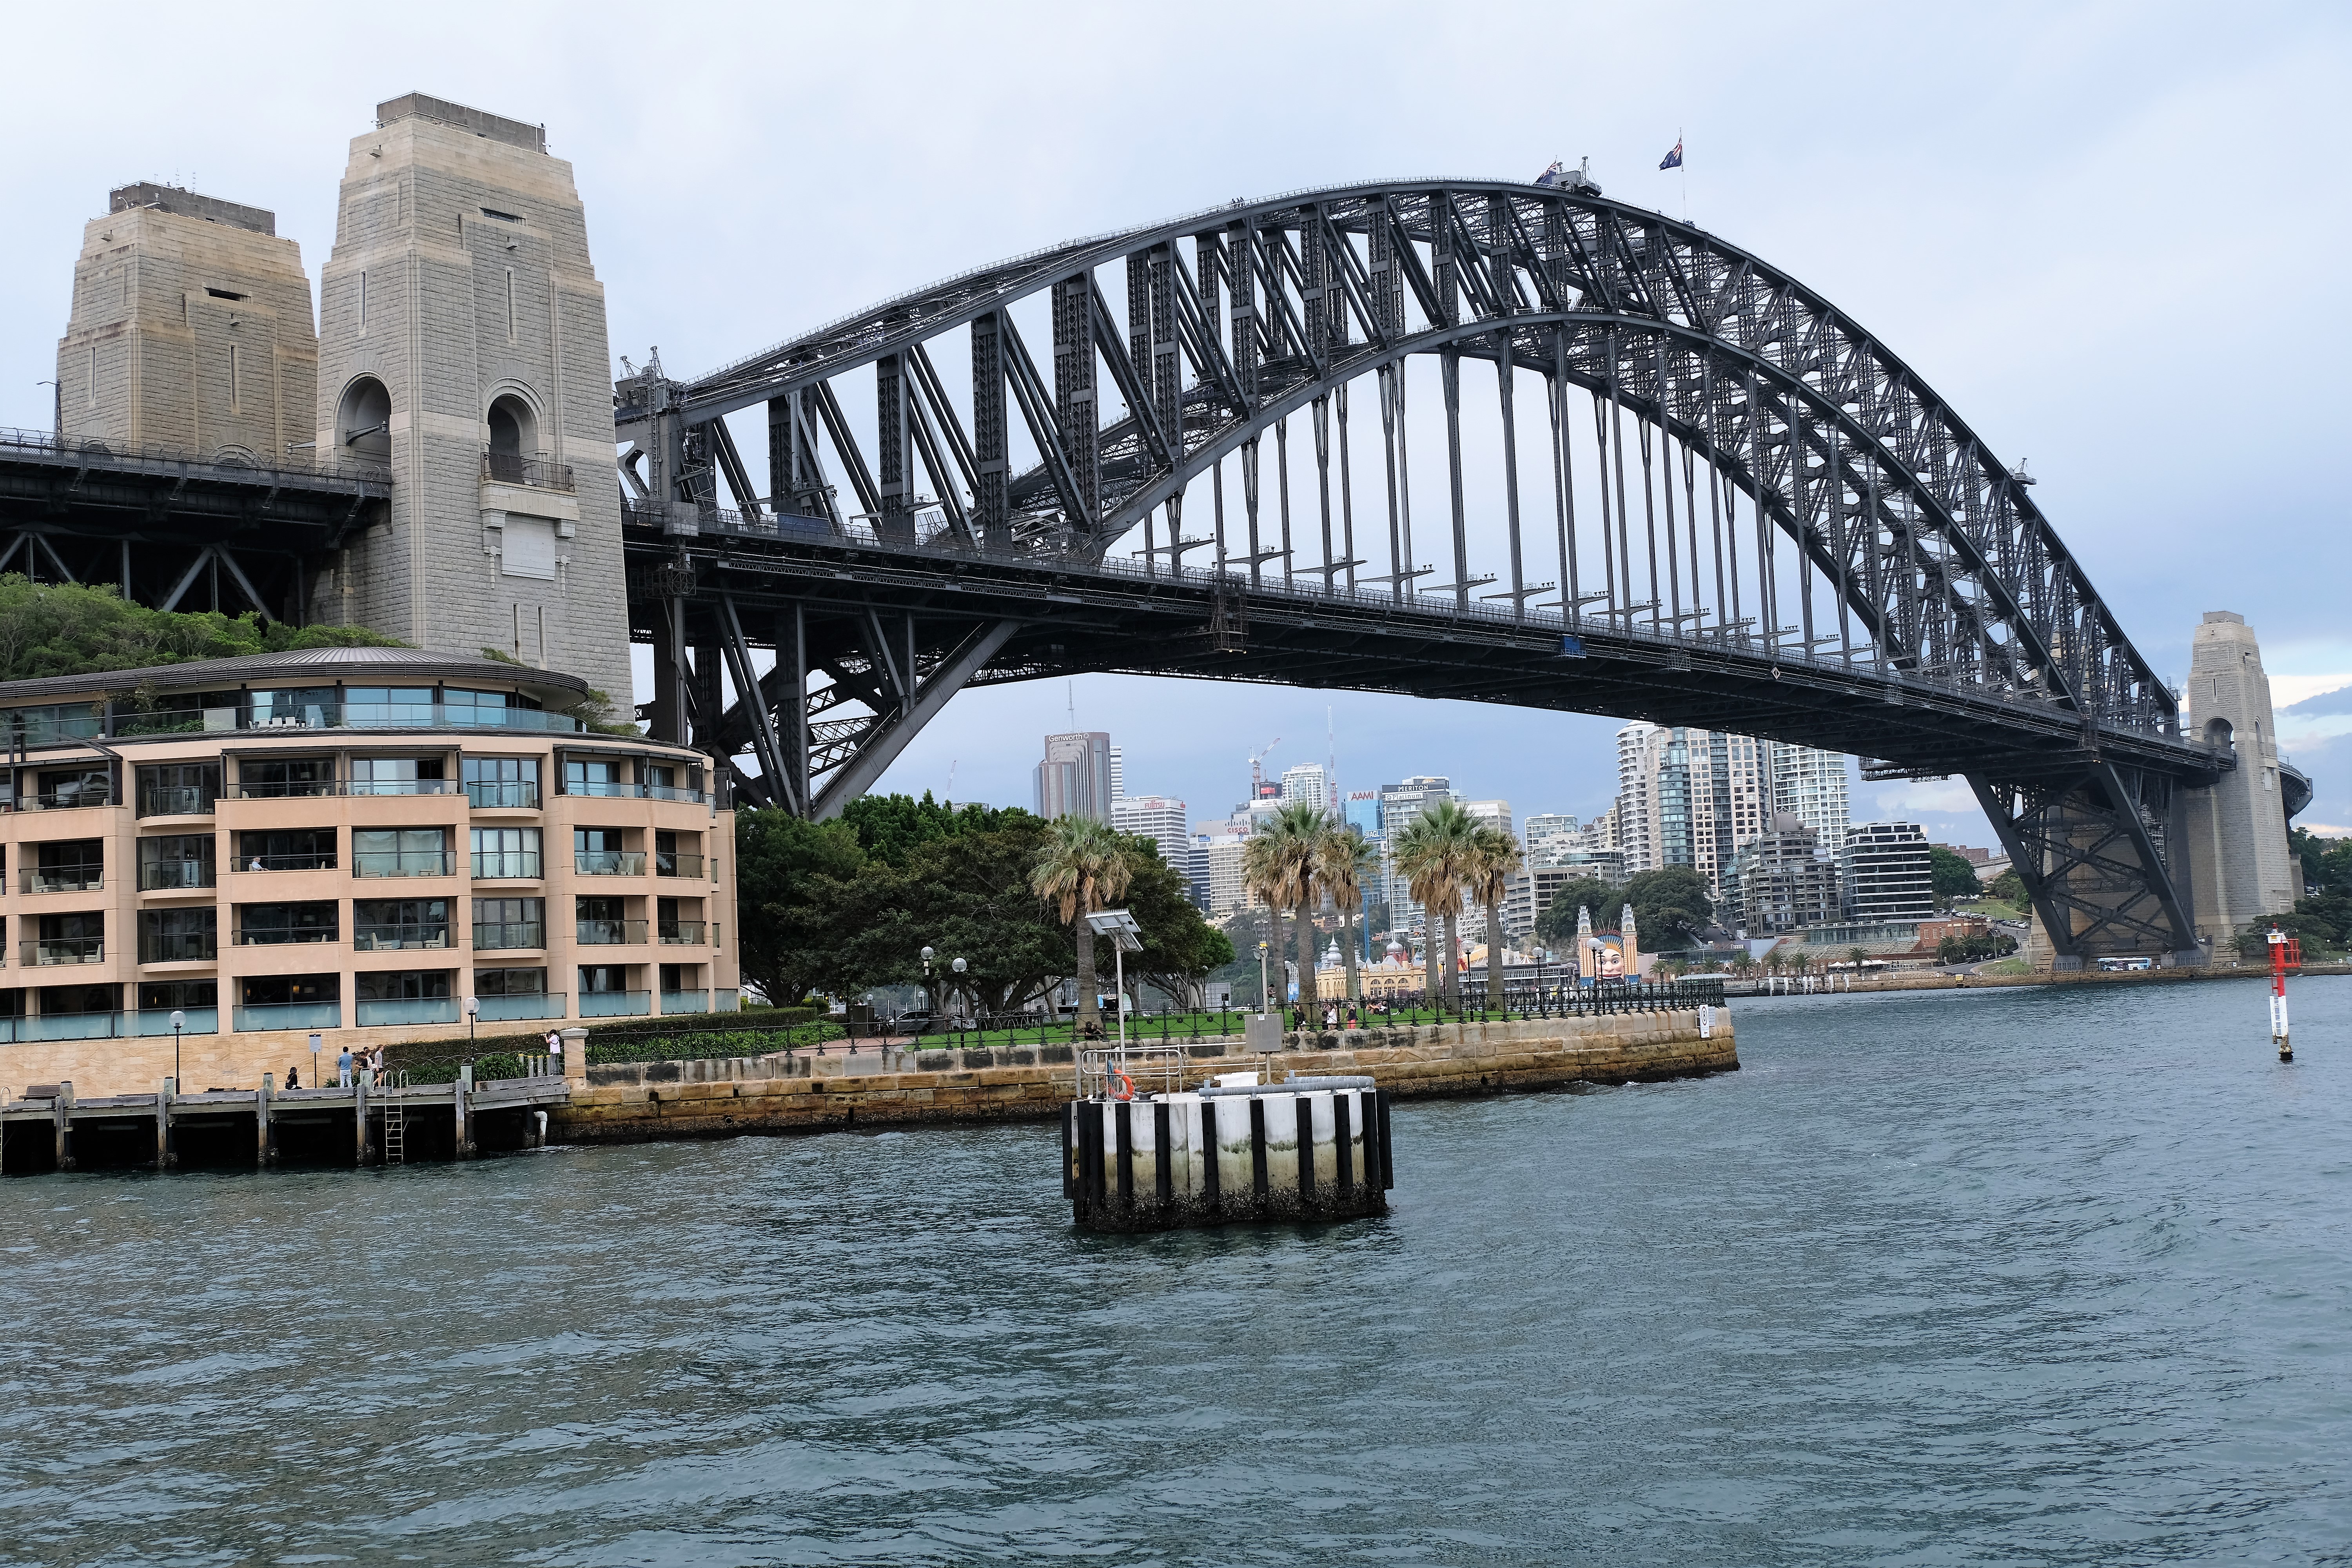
[[619, 181, 2230, 955]]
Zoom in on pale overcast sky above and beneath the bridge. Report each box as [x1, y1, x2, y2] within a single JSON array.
[[0, 0, 2352, 844]]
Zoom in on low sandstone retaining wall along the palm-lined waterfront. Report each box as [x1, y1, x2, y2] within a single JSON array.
[[548, 1009, 1740, 1143]]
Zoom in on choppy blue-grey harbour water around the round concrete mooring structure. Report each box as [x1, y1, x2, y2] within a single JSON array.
[[0, 980, 2352, 1563]]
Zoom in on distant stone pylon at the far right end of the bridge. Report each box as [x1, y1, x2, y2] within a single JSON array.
[[2176, 609, 2300, 959]]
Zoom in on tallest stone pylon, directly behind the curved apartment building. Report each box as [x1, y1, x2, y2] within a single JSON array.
[[313, 94, 630, 715]]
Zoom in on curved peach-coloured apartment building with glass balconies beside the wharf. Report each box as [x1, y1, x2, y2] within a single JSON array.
[[0, 649, 739, 1084]]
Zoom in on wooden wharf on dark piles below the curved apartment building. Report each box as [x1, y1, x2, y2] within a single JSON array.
[[0, 1074, 572, 1176]]
